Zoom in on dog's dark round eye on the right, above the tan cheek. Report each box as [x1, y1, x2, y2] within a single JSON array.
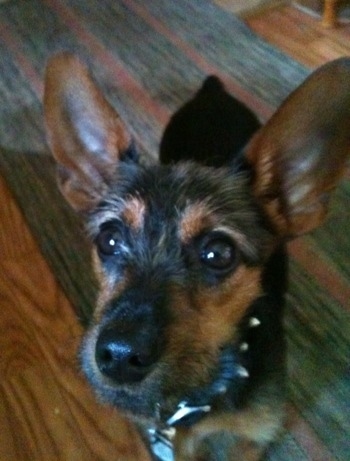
[[200, 237, 237, 273]]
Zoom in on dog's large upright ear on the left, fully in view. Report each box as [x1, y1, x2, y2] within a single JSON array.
[[44, 53, 131, 211]]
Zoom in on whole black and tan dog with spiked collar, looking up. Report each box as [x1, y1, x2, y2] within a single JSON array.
[[44, 53, 350, 461]]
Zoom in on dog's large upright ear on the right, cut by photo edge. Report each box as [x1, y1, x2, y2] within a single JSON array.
[[246, 58, 350, 238]]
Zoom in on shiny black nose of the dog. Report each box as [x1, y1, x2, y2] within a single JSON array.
[[95, 326, 160, 384]]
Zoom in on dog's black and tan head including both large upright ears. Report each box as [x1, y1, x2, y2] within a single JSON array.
[[45, 54, 350, 417]]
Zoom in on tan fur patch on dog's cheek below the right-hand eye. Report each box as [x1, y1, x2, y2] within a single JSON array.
[[167, 265, 261, 386]]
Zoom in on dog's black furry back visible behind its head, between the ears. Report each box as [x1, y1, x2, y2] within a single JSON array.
[[160, 76, 260, 166]]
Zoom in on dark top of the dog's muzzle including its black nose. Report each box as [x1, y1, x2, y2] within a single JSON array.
[[95, 289, 163, 385]]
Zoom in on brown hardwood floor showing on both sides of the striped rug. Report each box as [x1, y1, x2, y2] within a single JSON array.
[[0, 1, 350, 461]]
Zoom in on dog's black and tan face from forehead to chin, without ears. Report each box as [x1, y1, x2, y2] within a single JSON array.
[[82, 164, 271, 415]]
